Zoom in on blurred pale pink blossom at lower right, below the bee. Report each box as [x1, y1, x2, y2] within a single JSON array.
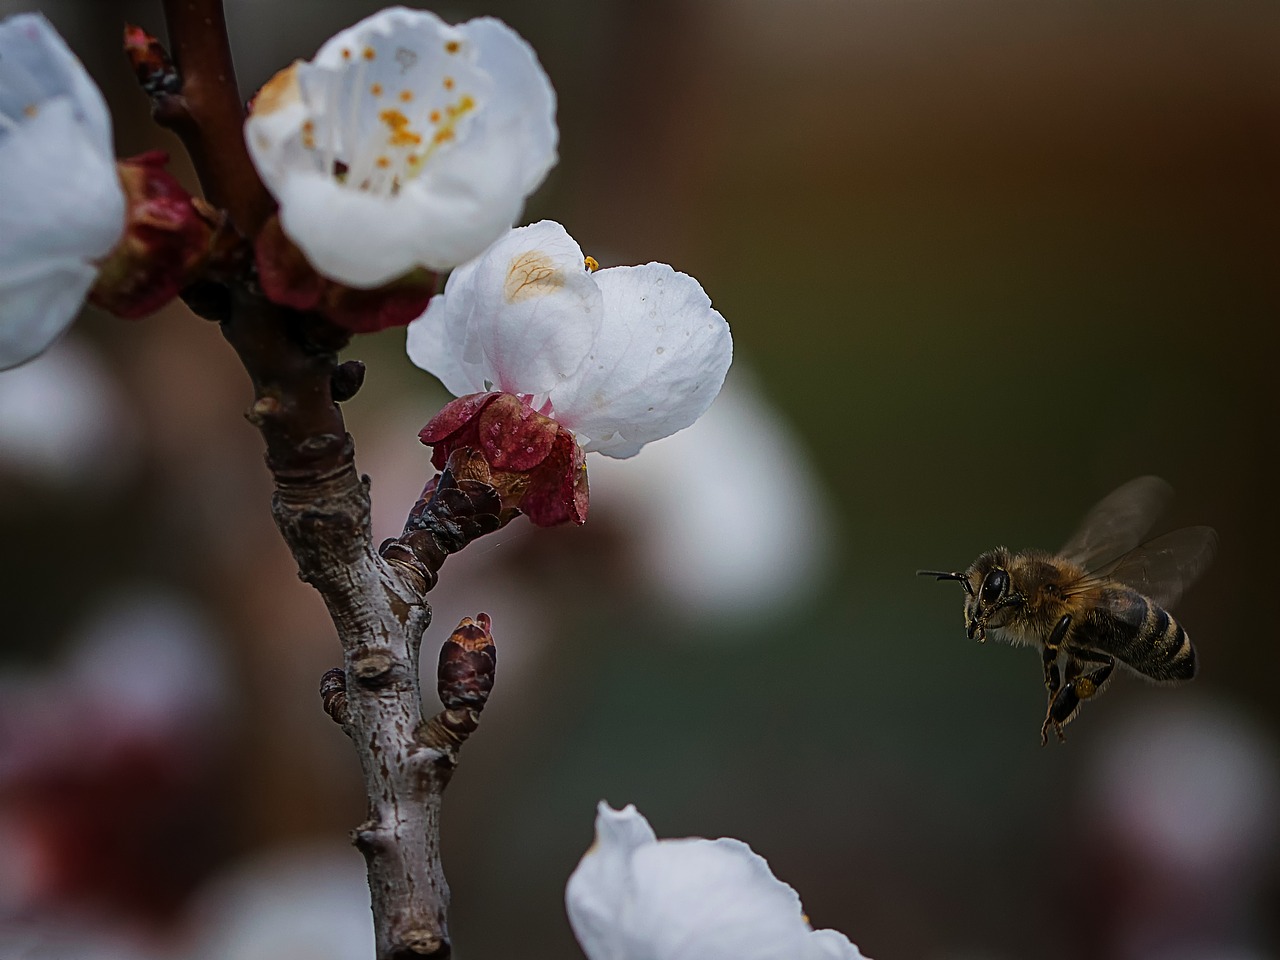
[[1061, 696, 1280, 960]]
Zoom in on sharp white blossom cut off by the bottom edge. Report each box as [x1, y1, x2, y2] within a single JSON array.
[[564, 803, 864, 960]]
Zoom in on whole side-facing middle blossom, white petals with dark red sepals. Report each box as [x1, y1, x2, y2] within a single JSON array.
[[408, 220, 733, 526]]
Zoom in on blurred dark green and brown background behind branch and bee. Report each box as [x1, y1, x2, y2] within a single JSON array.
[[0, 0, 1280, 960]]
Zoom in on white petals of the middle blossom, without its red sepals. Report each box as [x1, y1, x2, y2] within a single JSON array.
[[408, 220, 733, 458]]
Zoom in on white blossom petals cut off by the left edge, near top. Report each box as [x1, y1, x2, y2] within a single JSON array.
[[0, 14, 125, 370]]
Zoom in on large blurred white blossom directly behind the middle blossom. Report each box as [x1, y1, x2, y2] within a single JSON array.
[[591, 366, 833, 624]]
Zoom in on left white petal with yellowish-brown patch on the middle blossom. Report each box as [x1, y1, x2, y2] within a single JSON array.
[[408, 220, 602, 396]]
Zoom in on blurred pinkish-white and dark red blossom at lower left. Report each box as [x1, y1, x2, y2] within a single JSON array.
[[0, 593, 227, 922]]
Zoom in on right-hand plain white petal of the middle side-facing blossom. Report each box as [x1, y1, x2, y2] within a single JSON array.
[[550, 264, 733, 458]]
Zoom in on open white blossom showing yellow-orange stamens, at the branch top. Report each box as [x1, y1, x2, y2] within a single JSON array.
[[244, 6, 557, 289]]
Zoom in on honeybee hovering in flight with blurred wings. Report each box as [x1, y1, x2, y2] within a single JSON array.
[[916, 476, 1217, 746]]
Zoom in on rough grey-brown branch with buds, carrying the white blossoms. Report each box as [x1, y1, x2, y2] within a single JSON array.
[[134, 0, 502, 960]]
